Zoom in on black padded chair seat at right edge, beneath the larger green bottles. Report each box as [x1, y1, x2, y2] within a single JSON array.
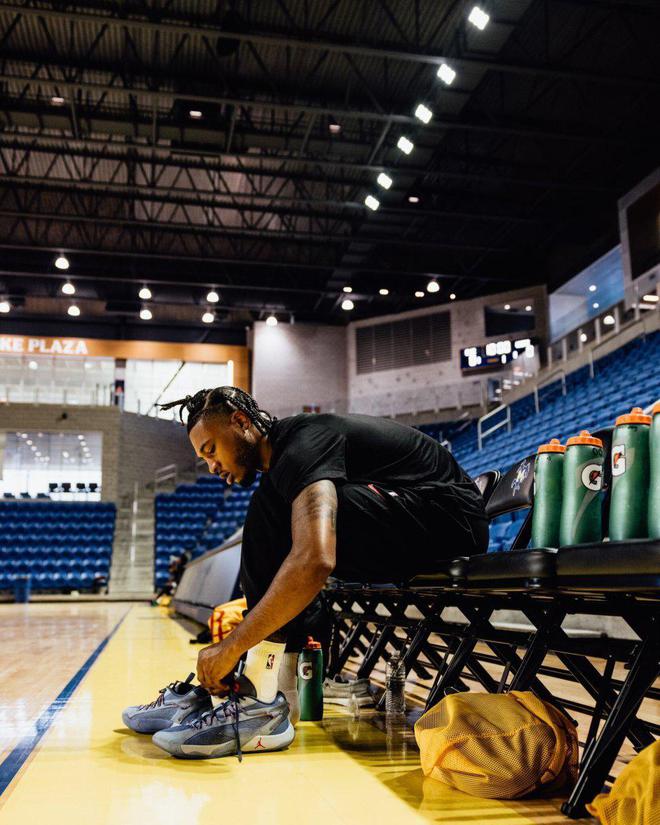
[[557, 539, 660, 598]]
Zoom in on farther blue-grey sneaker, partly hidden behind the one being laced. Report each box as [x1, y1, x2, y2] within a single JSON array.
[[121, 673, 213, 733]]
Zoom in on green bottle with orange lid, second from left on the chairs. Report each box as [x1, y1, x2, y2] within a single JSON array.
[[559, 430, 603, 547]]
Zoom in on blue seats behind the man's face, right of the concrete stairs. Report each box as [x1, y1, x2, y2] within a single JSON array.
[[154, 475, 253, 588]]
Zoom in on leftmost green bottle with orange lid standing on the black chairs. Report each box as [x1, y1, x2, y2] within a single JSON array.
[[529, 438, 566, 547]]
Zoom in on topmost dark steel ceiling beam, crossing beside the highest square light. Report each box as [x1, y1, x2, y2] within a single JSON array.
[[0, 2, 660, 89]]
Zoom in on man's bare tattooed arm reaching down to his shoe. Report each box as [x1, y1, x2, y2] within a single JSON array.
[[197, 479, 337, 690]]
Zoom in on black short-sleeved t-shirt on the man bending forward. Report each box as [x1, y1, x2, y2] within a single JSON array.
[[268, 414, 483, 507]]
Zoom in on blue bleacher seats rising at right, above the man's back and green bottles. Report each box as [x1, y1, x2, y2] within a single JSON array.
[[420, 333, 660, 552]]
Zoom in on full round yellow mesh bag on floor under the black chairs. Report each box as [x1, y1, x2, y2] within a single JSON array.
[[415, 691, 578, 799]]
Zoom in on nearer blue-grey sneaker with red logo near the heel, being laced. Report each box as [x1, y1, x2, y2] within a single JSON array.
[[153, 676, 295, 760]]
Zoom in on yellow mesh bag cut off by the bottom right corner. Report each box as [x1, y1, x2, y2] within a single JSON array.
[[587, 740, 660, 825]]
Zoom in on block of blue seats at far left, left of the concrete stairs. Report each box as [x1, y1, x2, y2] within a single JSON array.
[[0, 501, 116, 591]]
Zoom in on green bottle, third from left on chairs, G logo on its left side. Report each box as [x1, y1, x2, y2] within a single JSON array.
[[609, 407, 651, 541]]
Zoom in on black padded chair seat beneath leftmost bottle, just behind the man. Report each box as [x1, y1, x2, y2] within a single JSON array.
[[465, 547, 557, 590]]
